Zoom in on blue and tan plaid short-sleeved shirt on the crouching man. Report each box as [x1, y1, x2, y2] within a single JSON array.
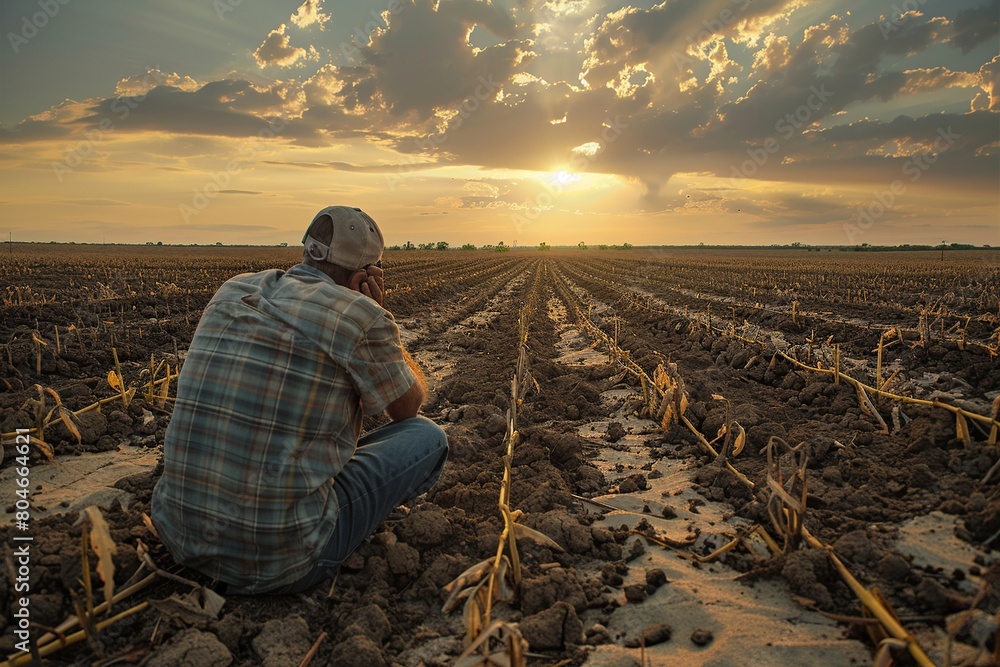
[[152, 264, 415, 593]]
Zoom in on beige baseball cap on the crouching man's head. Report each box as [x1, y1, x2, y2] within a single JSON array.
[[302, 206, 385, 271]]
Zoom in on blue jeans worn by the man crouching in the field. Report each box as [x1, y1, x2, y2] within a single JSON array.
[[262, 416, 448, 595]]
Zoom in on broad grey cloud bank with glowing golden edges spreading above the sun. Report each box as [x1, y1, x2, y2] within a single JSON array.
[[0, 0, 1000, 235]]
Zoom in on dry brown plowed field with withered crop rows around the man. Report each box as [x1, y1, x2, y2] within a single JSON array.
[[0, 245, 1000, 667]]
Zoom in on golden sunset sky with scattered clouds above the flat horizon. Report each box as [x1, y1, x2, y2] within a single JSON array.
[[0, 0, 1000, 246]]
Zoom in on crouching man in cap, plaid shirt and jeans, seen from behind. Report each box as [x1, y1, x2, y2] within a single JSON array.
[[152, 206, 448, 594]]
